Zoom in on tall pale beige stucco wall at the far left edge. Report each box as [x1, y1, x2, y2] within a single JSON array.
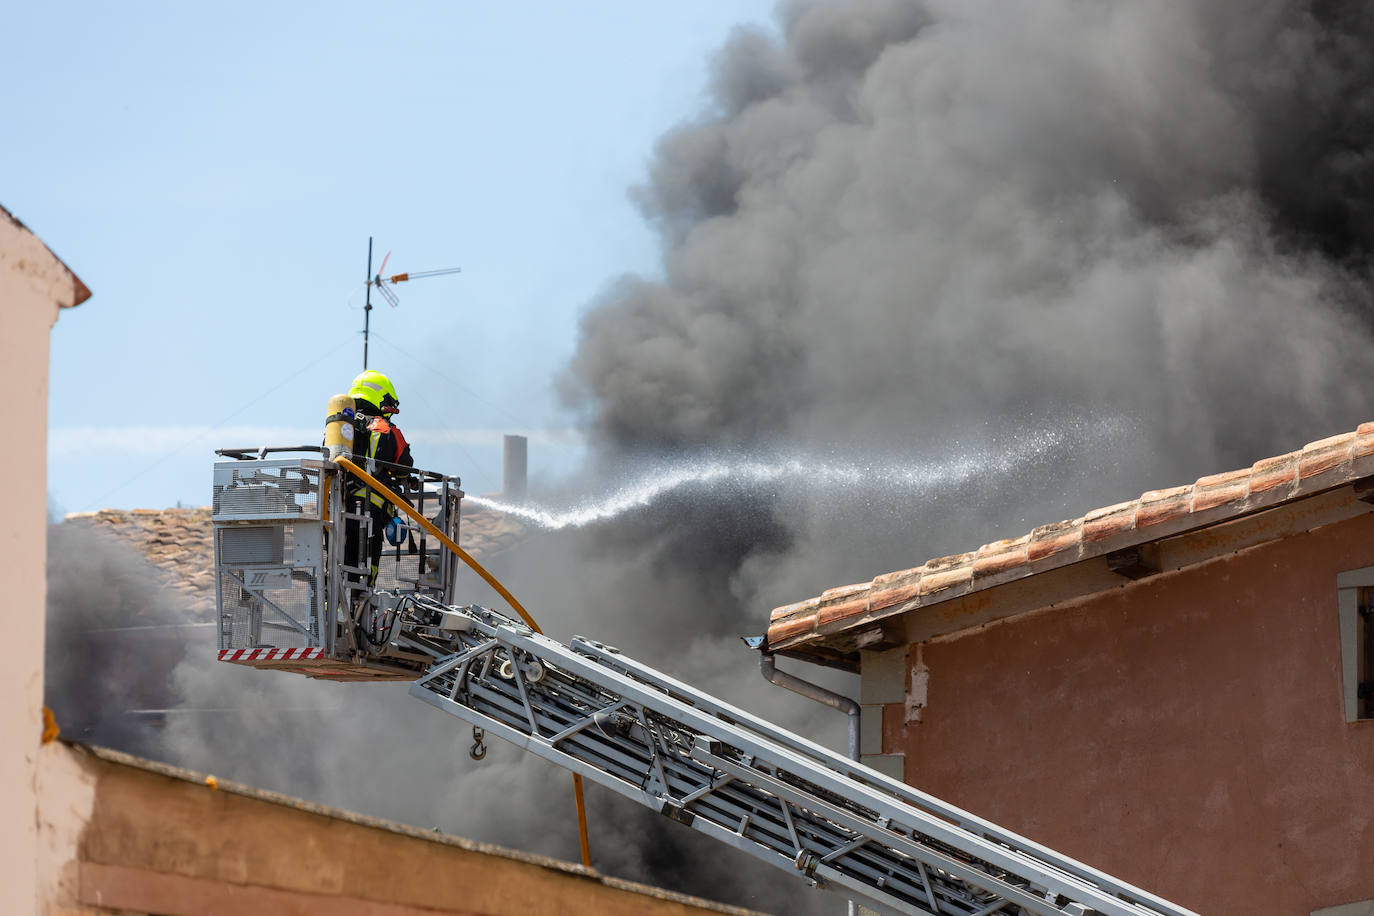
[[0, 209, 89, 913]]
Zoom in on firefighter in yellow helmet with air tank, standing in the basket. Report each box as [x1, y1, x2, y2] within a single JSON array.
[[344, 369, 415, 586]]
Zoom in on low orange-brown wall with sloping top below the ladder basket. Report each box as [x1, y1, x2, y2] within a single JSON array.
[[37, 742, 761, 916]]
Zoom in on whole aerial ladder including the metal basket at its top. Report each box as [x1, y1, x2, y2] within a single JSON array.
[[213, 446, 1195, 916]]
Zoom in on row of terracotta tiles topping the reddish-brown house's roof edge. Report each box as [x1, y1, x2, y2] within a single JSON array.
[[768, 422, 1374, 648]]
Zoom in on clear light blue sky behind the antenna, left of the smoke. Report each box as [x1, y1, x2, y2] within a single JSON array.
[[10, 0, 772, 512]]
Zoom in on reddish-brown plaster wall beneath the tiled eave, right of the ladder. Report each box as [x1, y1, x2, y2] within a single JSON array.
[[882, 515, 1374, 916]]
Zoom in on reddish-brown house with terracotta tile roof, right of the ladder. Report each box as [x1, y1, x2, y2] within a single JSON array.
[[768, 423, 1374, 916]]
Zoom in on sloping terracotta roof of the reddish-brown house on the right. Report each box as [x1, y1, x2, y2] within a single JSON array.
[[767, 423, 1374, 667]]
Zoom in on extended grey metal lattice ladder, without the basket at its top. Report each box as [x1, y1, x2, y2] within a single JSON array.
[[392, 596, 1195, 916]]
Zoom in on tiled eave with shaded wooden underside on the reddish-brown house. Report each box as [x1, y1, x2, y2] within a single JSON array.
[[768, 423, 1374, 665]]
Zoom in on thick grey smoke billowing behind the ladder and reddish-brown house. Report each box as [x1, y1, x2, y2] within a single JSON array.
[[48, 0, 1374, 913]]
